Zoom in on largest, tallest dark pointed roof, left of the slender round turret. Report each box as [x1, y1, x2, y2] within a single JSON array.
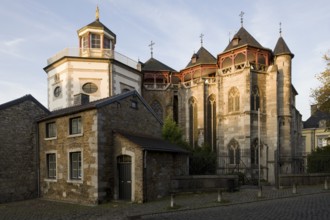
[[224, 27, 264, 52]]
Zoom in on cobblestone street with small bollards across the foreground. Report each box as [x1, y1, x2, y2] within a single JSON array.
[[0, 185, 330, 219]]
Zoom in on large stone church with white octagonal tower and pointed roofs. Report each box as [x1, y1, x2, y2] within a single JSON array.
[[44, 6, 303, 187]]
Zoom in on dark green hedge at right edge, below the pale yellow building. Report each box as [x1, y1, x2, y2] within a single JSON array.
[[307, 146, 330, 173]]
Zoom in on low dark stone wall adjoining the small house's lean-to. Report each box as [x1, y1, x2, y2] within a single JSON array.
[[171, 175, 238, 192]]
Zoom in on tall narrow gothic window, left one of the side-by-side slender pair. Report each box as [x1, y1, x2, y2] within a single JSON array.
[[189, 97, 198, 147]]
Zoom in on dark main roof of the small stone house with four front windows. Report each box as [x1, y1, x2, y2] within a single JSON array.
[[39, 90, 163, 123]]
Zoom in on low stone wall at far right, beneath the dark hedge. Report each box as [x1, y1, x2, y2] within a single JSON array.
[[279, 173, 330, 186]]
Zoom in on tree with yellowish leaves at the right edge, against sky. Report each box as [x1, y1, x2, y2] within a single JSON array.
[[311, 51, 330, 113]]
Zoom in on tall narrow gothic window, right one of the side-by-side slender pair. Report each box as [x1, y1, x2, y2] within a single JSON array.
[[204, 94, 216, 150]]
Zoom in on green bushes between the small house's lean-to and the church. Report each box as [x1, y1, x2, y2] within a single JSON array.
[[162, 117, 216, 175]]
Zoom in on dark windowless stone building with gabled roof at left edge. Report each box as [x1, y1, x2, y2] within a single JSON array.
[[0, 95, 49, 203]]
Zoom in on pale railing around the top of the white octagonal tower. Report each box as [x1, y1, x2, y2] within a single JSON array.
[[47, 48, 138, 69]]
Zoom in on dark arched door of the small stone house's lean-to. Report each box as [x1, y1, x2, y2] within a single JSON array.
[[117, 155, 132, 200]]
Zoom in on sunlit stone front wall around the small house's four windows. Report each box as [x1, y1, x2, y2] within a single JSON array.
[[39, 110, 99, 204]]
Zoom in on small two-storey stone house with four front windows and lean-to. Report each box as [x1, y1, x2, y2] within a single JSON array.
[[39, 91, 188, 204]]
